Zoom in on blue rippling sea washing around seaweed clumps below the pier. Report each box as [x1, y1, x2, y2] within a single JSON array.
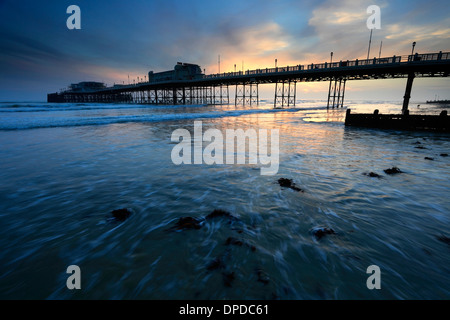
[[0, 100, 450, 300]]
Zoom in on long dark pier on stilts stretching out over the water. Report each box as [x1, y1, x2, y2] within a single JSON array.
[[48, 52, 450, 113]]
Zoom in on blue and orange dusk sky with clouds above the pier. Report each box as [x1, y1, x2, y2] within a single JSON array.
[[0, 0, 450, 101]]
